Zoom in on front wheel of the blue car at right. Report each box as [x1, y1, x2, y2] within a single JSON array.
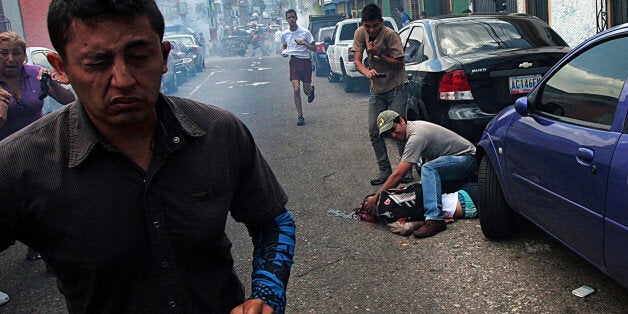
[[478, 156, 517, 240]]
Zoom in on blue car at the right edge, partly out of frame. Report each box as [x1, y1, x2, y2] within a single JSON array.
[[477, 24, 628, 287]]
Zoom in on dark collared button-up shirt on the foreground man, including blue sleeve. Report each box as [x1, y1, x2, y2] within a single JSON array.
[[0, 95, 294, 313]]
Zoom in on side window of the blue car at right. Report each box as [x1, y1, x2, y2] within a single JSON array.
[[535, 37, 628, 130]]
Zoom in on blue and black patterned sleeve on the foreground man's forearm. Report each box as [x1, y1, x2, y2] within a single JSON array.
[[249, 211, 296, 314]]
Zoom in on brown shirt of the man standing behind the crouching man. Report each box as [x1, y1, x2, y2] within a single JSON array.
[[353, 25, 408, 93]]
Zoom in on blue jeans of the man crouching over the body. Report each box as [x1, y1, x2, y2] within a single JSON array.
[[421, 155, 477, 220]]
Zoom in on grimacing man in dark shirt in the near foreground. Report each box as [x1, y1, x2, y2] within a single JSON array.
[[0, 0, 295, 313]]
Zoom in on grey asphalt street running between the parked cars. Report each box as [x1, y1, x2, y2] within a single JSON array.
[[0, 56, 628, 313]]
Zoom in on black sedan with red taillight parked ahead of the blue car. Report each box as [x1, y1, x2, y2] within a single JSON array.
[[399, 13, 570, 143]]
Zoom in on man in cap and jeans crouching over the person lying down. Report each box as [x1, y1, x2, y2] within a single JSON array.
[[364, 110, 477, 238]]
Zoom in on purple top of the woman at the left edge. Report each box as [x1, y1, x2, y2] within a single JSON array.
[[0, 64, 44, 140]]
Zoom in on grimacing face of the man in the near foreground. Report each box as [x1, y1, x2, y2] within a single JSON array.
[[49, 16, 170, 130]]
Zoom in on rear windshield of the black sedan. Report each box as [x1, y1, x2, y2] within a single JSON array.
[[437, 20, 567, 56]]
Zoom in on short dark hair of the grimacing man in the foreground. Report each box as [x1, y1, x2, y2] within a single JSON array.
[[48, 0, 165, 57]]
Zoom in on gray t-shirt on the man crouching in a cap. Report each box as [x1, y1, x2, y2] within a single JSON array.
[[401, 121, 475, 163]]
